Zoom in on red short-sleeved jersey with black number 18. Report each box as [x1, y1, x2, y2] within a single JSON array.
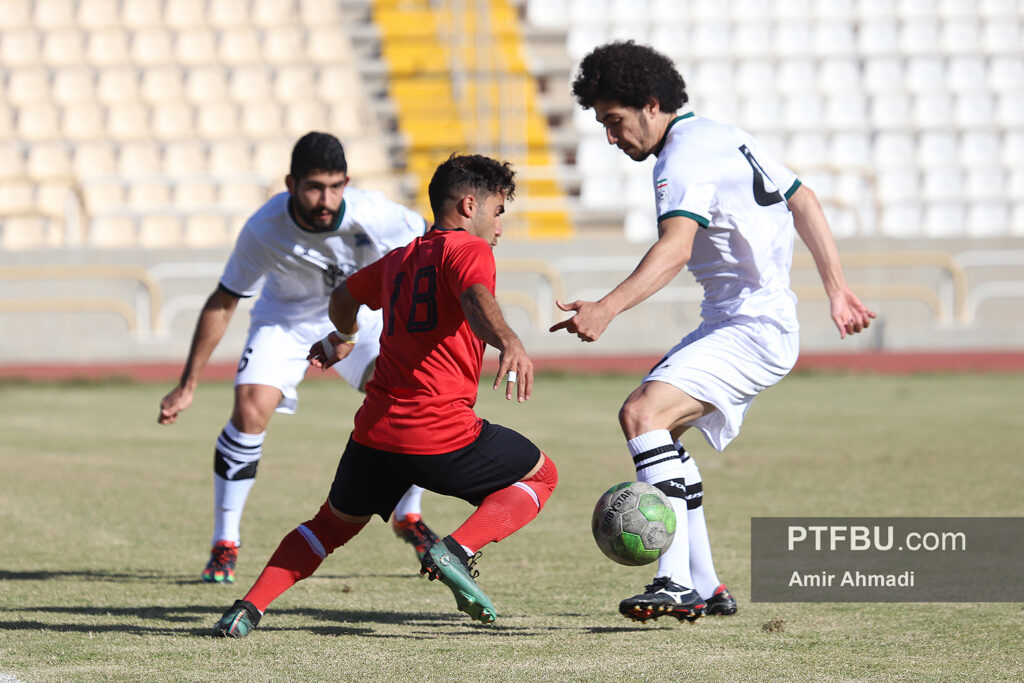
[[345, 228, 495, 455]]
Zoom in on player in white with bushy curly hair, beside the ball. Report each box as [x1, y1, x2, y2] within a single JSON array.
[[551, 41, 874, 621]]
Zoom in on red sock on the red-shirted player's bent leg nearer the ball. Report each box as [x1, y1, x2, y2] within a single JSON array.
[[452, 456, 558, 554]]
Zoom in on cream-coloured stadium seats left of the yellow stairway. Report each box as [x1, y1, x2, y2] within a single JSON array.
[[0, 0, 395, 250]]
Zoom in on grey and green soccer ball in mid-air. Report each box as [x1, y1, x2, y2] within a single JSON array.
[[591, 481, 676, 566]]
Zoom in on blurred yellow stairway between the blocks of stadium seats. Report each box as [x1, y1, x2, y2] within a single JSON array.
[[374, 0, 572, 239]]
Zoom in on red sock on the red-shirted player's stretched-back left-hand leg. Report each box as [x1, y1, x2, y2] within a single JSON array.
[[245, 503, 366, 612]]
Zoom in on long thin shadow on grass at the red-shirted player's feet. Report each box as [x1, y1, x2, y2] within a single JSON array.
[[0, 604, 540, 640]]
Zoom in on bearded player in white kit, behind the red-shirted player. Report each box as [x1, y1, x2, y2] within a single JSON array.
[[158, 132, 437, 584]]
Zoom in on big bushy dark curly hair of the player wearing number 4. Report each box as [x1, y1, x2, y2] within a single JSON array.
[[572, 40, 689, 112]]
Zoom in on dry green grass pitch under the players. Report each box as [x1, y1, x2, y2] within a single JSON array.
[[0, 375, 1024, 681]]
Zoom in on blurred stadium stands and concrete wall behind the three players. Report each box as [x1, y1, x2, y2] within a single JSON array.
[[0, 0, 1024, 366]]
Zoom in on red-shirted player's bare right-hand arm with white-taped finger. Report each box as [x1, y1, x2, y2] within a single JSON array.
[[459, 285, 534, 403]]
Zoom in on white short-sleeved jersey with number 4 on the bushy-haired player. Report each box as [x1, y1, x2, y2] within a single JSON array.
[[653, 113, 800, 332]]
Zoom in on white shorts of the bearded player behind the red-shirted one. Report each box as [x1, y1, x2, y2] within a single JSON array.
[[234, 306, 383, 413]]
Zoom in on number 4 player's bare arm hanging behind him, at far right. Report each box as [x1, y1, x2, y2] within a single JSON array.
[[790, 185, 876, 338]]
